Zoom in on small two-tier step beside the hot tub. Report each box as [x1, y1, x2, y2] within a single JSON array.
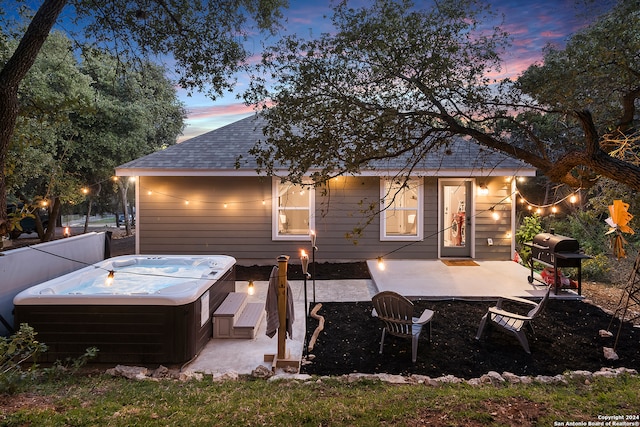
[[213, 292, 264, 339]]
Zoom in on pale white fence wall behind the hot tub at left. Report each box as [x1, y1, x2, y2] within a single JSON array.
[[0, 232, 111, 336]]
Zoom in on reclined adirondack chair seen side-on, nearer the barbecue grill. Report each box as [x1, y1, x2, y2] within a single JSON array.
[[476, 285, 553, 354]]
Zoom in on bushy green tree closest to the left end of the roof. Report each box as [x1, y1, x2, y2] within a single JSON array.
[[71, 51, 186, 234]]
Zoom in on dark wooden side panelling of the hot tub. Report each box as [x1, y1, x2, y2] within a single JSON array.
[[15, 267, 235, 365]]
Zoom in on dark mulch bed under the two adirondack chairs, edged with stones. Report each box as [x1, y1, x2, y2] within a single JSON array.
[[303, 300, 640, 379]]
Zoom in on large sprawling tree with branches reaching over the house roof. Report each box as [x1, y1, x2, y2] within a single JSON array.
[[245, 0, 640, 190]]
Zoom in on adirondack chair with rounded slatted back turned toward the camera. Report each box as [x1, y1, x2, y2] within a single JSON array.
[[371, 291, 433, 363]]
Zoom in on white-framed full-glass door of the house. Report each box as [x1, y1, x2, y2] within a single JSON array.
[[440, 180, 472, 258]]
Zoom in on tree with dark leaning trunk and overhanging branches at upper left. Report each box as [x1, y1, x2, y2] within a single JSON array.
[[0, 0, 285, 235]]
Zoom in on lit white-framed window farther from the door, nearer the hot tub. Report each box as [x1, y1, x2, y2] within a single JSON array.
[[272, 179, 315, 240]]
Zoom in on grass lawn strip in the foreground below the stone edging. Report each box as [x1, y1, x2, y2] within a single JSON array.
[[0, 375, 640, 427]]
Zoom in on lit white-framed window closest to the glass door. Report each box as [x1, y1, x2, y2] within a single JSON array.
[[380, 178, 424, 241]]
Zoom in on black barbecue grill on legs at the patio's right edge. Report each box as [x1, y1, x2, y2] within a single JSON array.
[[525, 233, 591, 295]]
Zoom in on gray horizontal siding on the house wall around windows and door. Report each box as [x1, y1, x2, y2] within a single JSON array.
[[137, 176, 510, 265]]
